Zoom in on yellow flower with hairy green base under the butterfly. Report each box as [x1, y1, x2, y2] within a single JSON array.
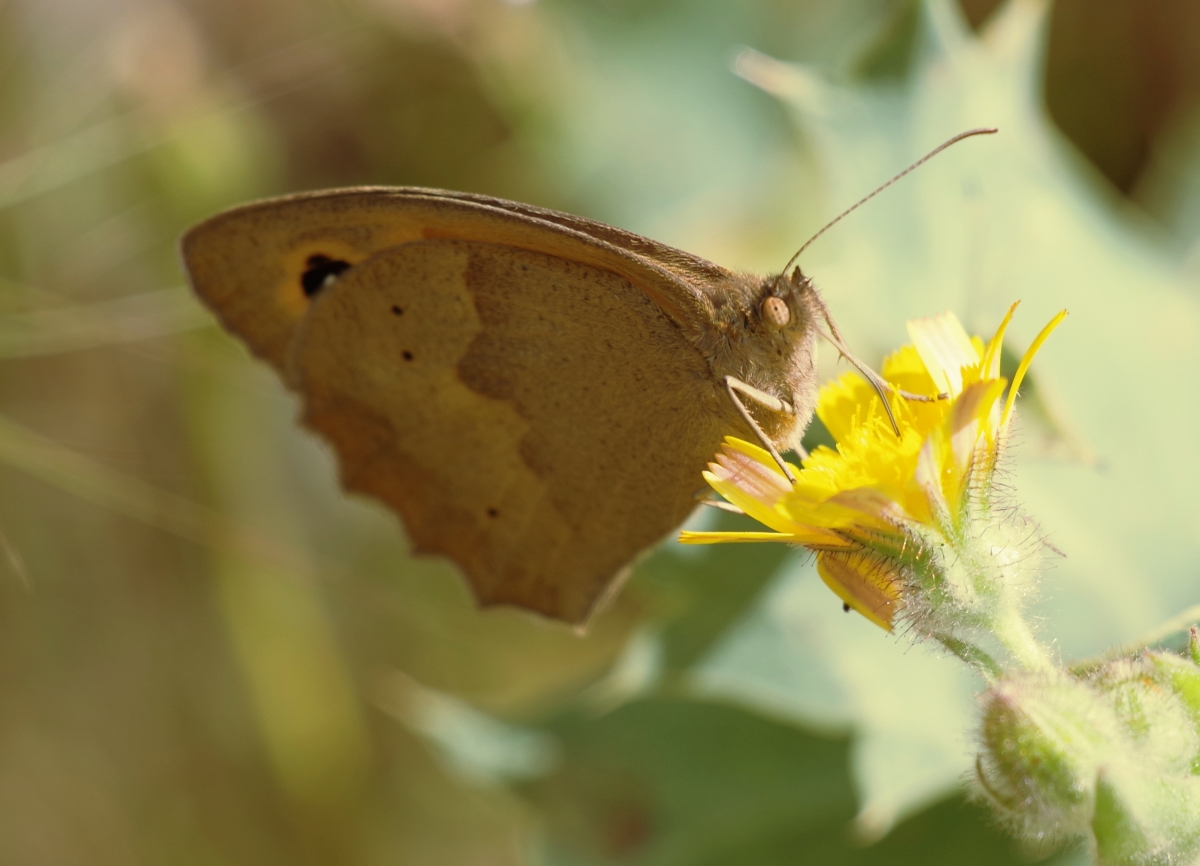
[[679, 303, 1067, 631]]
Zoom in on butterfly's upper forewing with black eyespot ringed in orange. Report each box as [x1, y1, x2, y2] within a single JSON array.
[[181, 187, 730, 373]]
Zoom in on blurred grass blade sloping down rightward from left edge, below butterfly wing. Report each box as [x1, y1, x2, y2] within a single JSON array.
[[0, 415, 312, 572]]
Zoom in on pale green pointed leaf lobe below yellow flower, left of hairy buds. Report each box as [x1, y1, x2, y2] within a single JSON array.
[[694, 559, 979, 836]]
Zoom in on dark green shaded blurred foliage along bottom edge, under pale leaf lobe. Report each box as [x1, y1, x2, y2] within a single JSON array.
[[524, 699, 1078, 866]]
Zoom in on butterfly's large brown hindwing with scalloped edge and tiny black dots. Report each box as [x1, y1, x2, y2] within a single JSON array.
[[289, 240, 721, 623]]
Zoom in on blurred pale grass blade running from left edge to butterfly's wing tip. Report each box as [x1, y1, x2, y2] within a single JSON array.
[[0, 285, 212, 359]]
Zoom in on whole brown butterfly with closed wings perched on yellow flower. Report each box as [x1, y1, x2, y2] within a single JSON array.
[[175, 131, 977, 624]]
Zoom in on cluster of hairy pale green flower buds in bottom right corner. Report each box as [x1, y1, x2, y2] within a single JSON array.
[[976, 652, 1200, 866]]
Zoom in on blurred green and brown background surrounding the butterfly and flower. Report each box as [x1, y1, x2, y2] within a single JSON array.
[[7, 0, 1200, 866]]
